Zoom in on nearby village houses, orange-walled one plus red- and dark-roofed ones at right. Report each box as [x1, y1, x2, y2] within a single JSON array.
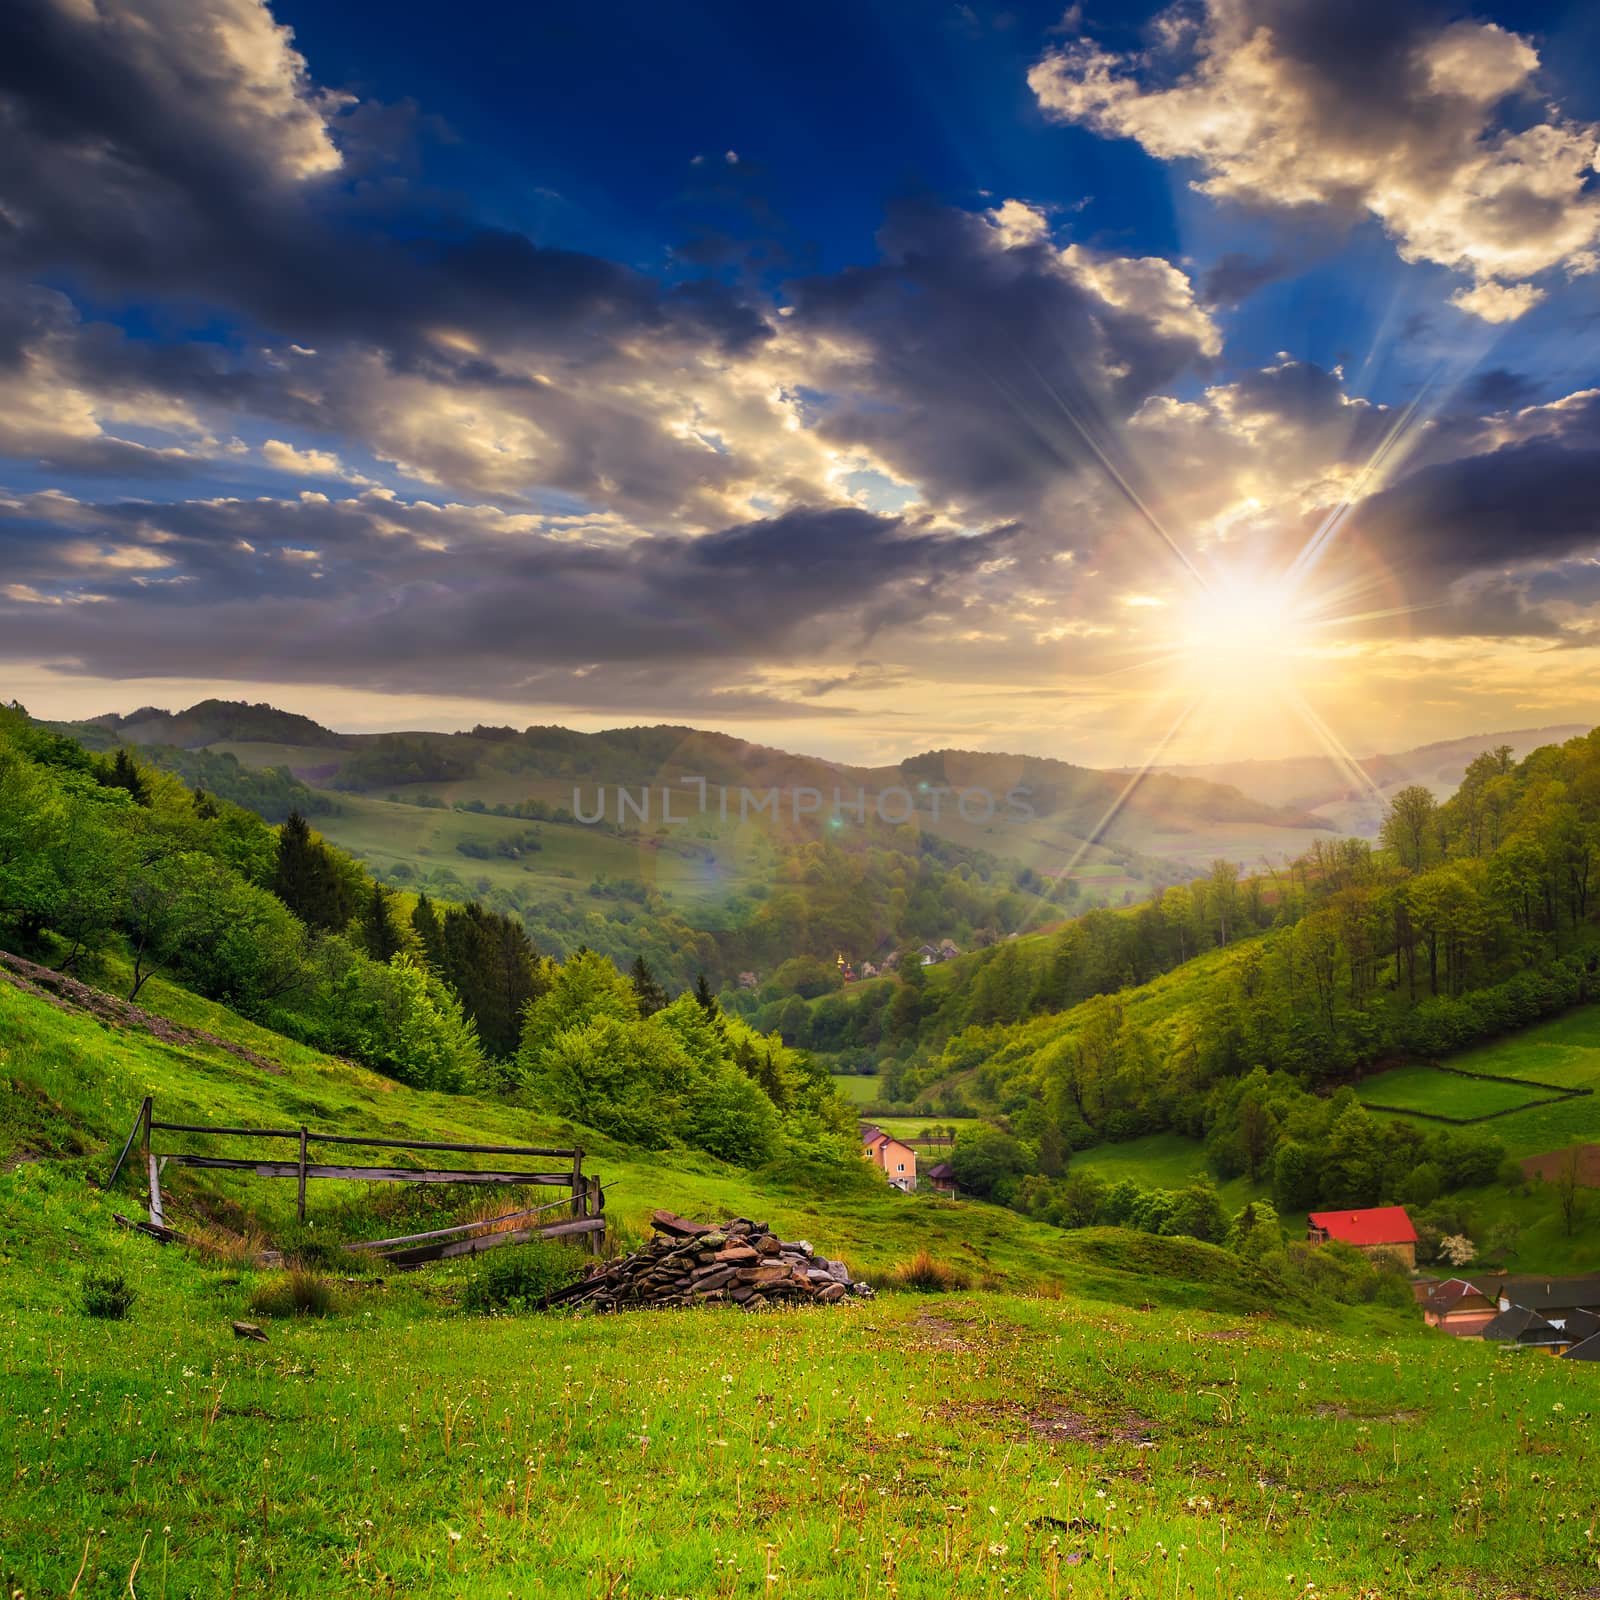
[[861, 1122, 1600, 1362]]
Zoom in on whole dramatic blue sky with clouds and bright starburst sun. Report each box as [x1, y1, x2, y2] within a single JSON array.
[[0, 0, 1600, 765]]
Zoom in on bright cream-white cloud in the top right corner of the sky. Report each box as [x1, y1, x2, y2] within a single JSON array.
[[1029, 0, 1600, 322]]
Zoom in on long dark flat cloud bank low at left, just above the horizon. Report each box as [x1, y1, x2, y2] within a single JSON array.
[[0, 494, 1003, 694]]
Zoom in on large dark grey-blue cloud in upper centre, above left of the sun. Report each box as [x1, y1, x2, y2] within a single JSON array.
[[792, 203, 1210, 515]]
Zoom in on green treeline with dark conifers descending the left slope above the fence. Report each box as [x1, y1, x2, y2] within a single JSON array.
[[0, 707, 859, 1171]]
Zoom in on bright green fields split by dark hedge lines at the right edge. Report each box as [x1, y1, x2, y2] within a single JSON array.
[[1360, 1005, 1600, 1158]]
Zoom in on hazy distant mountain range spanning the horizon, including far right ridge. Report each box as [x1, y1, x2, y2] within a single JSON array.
[[59, 699, 1586, 904]]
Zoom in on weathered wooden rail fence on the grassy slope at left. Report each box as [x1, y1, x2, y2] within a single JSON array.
[[106, 1094, 605, 1267]]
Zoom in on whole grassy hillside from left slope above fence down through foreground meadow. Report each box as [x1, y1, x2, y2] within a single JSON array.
[[0, 986, 1595, 1600]]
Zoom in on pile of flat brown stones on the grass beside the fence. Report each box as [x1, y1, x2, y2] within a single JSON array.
[[550, 1211, 872, 1310]]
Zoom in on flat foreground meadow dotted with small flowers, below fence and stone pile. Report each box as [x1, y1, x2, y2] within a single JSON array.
[[12, 1256, 1597, 1600]]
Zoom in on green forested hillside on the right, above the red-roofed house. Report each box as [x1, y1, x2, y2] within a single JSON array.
[[732, 730, 1600, 1235]]
